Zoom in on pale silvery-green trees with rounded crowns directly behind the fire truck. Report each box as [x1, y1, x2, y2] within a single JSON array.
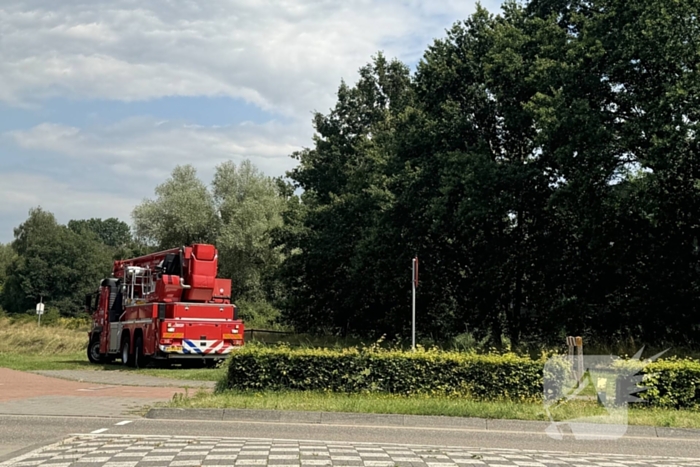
[[133, 160, 290, 322]]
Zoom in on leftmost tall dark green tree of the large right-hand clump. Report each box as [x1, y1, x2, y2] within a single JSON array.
[[278, 54, 411, 334]]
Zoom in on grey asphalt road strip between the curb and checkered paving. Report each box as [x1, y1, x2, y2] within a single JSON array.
[[0, 415, 700, 462]]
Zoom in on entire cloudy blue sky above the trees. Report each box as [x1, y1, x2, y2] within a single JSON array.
[[0, 0, 501, 242]]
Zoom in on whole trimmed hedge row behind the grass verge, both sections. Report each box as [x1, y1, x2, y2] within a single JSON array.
[[226, 346, 700, 409]]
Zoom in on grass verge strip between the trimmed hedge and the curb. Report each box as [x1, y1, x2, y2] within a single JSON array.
[[161, 391, 700, 428]]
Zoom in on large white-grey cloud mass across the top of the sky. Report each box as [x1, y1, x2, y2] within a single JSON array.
[[0, 0, 498, 116]]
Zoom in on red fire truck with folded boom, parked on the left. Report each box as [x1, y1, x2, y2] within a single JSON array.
[[85, 244, 243, 367]]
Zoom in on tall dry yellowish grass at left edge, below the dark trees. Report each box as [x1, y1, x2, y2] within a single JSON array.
[[0, 317, 88, 355]]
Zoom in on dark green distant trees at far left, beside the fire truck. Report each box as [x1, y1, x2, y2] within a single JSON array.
[[0, 212, 147, 316]]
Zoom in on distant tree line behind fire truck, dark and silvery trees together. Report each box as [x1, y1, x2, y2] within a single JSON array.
[[0, 160, 287, 326]]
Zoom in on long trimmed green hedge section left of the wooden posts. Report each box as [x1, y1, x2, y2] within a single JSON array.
[[227, 346, 544, 401]]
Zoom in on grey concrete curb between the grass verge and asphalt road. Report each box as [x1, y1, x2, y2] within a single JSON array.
[[145, 408, 700, 439]]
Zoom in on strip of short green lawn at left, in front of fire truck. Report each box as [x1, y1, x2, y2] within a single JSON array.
[[0, 352, 225, 381]]
